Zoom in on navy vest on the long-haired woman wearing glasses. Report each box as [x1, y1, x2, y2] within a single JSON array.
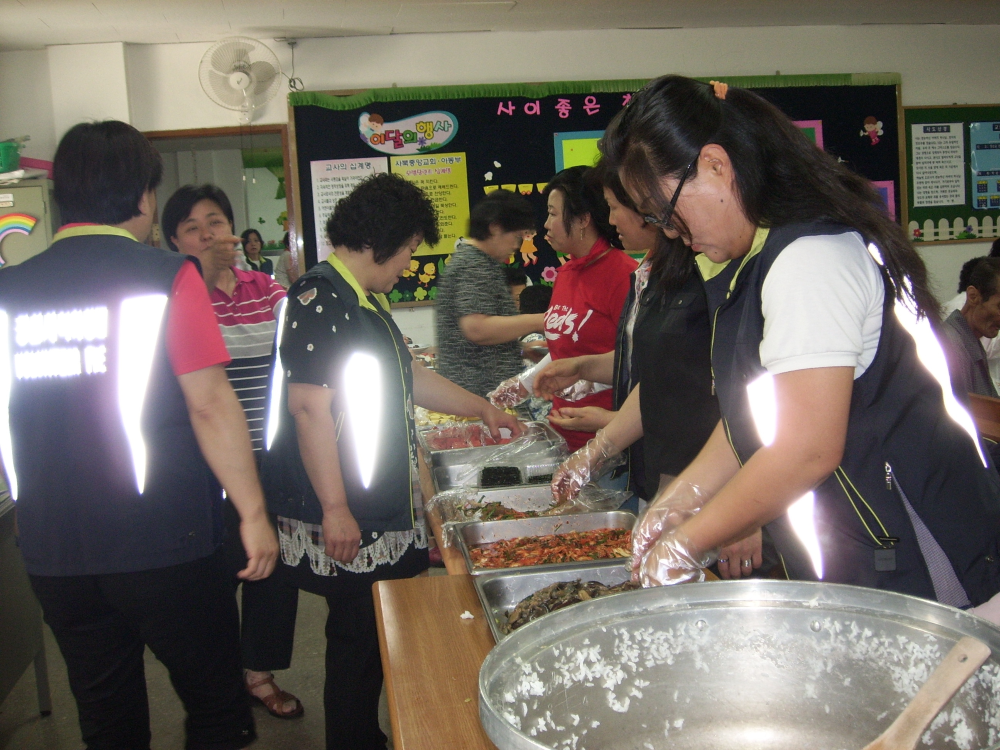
[[707, 224, 1000, 605]]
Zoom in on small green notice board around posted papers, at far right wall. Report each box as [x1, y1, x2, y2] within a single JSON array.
[[901, 104, 1000, 244]]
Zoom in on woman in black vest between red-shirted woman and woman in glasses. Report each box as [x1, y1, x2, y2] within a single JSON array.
[[534, 162, 751, 560]]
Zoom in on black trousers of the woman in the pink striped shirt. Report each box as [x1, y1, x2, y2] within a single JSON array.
[[222, 502, 299, 672]]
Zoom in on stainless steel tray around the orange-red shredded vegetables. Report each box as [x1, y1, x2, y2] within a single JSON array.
[[456, 510, 635, 576]]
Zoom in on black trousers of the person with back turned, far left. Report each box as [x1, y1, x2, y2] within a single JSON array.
[[31, 551, 256, 750]]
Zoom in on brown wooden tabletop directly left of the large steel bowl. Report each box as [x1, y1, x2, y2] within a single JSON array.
[[373, 575, 495, 750]]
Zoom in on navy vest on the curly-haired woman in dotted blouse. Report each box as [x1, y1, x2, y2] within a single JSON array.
[[261, 262, 417, 532]]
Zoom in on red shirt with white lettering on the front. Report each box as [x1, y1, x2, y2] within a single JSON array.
[[545, 240, 639, 451]]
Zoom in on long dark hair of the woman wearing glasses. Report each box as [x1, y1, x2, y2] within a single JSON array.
[[604, 75, 939, 321]]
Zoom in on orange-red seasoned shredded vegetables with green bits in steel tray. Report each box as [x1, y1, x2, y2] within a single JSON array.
[[470, 529, 632, 568]]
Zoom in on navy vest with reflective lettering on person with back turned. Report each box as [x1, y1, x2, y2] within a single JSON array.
[[0, 235, 221, 576]]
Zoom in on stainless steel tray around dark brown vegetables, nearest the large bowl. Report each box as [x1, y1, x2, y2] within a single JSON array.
[[473, 558, 632, 643]]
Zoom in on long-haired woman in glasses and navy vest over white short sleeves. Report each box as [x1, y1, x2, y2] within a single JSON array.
[[605, 76, 1000, 607]]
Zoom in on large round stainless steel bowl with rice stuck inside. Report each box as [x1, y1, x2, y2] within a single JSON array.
[[479, 581, 1000, 750]]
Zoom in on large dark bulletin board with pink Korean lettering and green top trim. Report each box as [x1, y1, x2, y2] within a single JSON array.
[[288, 73, 905, 306]]
